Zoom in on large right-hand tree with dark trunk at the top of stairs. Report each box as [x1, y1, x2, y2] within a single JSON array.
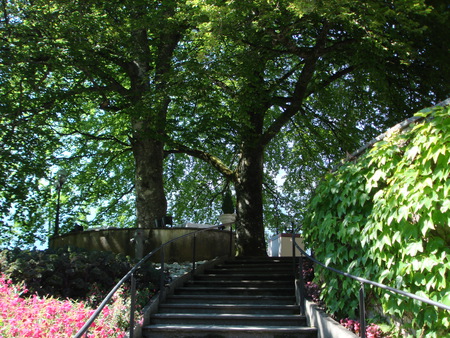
[[166, 0, 448, 255]]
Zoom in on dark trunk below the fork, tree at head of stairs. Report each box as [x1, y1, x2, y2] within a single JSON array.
[[235, 143, 267, 256]]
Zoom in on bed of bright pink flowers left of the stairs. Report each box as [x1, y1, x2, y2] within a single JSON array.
[[0, 274, 127, 338]]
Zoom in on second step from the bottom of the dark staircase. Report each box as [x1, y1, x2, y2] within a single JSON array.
[[151, 313, 306, 327]]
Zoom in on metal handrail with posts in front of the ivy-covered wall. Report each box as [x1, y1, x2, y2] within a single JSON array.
[[292, 238, 450, 338]]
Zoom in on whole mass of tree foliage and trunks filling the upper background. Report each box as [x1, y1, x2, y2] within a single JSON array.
[[0, 0, 450, 254]]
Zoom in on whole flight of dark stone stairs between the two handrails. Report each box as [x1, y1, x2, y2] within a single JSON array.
[[143, 257, 317, 338]]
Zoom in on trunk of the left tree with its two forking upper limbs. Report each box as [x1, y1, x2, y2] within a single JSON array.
[[129, 2, 181, 228]]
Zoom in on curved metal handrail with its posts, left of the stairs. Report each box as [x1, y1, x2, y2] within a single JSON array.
[[73, 222, 234, 338]]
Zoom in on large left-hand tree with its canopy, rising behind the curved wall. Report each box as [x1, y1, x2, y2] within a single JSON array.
[[0, 0, 187, 244]]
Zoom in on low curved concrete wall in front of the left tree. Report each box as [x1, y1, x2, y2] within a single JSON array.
[[49, 228, 234, 262]]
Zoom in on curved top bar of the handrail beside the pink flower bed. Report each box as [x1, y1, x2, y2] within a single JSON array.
[[73, 222, 234, 338]]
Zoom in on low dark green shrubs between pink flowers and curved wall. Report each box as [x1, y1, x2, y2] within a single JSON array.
[[0, 249, 159, 301]]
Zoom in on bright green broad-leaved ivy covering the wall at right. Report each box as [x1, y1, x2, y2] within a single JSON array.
[[304, 106, 450, 337]]
